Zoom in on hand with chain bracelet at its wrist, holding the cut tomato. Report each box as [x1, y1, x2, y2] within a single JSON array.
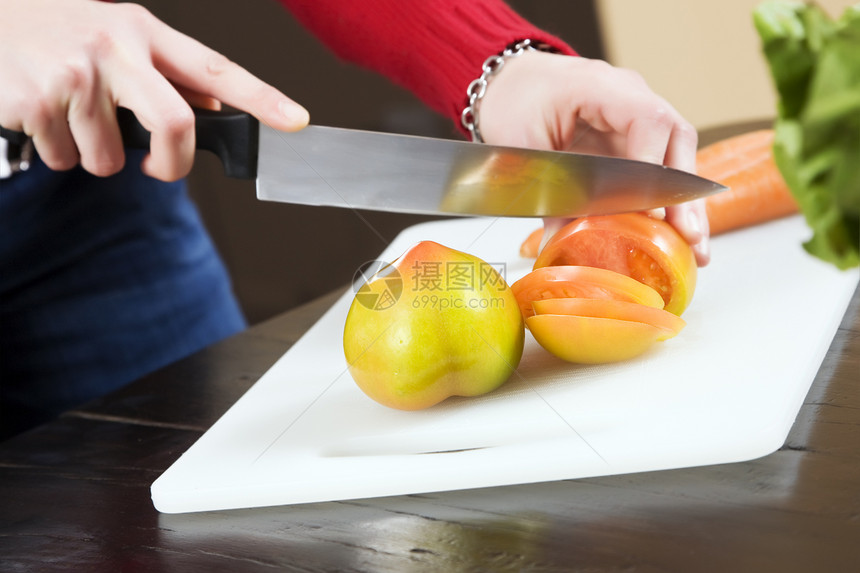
[[480, 52, 710, 266]]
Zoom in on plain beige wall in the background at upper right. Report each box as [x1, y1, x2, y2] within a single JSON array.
[[596, 0, 852, 129]]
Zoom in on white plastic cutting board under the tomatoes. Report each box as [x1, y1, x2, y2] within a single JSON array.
[[152, 216, 858, 513]]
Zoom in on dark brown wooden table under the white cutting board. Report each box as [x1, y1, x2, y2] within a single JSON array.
[[0, 280, 860, 572]]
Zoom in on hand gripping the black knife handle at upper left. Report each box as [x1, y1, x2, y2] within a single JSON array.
[[0, 0, 308, 181]]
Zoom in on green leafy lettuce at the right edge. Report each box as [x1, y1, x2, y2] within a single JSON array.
[[753, 0, 860, 269]]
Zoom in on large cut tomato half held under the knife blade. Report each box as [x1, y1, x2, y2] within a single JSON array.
[[534, 213, 697, 316]]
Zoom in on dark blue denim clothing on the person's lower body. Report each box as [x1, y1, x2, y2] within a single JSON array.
[[0, 152, 245, 437]]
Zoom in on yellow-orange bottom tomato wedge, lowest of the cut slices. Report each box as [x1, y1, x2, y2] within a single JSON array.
[[526, 314, 666, 364]]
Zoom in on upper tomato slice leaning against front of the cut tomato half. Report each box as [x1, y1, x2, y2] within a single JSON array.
[[511, 265, 663, 318]]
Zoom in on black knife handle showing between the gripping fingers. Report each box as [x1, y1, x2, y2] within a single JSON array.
[[0, 107, 260, 179]]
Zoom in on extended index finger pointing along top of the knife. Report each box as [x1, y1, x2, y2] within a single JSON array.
[[153, 26, 309, 131]]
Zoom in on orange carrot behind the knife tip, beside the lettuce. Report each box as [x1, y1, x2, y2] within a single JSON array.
[[696, 129, 798, 235]]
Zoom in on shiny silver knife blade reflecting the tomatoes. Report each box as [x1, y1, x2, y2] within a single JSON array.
[[257, 125, 725, 217]]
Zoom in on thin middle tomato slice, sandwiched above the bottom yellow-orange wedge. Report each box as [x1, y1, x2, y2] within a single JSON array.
[[532, 298, 687, 340]]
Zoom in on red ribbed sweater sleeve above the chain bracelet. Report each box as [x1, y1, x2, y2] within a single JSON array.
[[281, 0, 575, 131]]
